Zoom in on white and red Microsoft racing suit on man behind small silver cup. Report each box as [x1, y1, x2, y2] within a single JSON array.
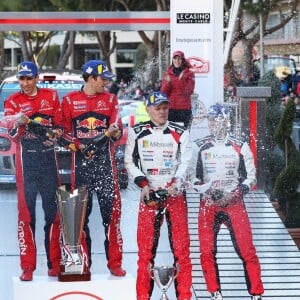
[[125, 121, 192, 300]]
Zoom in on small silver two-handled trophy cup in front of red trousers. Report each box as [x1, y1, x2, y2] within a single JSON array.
[[148, 264, 179, 300]]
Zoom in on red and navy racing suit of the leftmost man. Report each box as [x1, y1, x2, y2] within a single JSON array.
[[4, 88, 62, 270]]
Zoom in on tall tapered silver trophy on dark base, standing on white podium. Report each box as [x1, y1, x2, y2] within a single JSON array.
[[56, 186, 91, 281]]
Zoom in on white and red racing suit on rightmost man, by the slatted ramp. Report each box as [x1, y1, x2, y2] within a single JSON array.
[[194, 136, 264, 295]]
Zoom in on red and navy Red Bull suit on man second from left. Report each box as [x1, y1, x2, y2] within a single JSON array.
[[62, 90, 123, 269]]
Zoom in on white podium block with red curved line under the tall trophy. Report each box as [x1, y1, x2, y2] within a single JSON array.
[[13, 274, 136, 300]]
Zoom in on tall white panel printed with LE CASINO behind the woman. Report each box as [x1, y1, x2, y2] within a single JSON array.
[[170, 0, 223, 136]]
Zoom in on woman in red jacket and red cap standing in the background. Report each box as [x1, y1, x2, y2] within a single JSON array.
[[160, 51, 195, 128]]
